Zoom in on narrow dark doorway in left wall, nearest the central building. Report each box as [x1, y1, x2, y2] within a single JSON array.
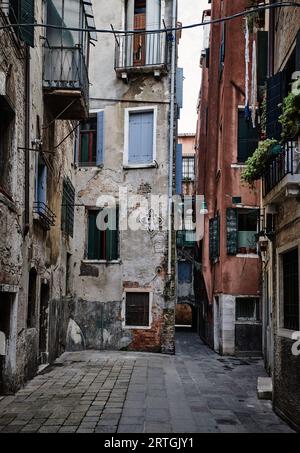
[[39, 283, 50, 365]]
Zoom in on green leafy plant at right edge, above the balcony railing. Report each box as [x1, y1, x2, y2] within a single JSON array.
[[279, 78, 300, 141]]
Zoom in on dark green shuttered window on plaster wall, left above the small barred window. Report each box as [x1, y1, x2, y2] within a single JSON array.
[[87, 209, 119, 261]]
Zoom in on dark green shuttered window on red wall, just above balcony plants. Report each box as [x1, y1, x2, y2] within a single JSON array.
[[238, 110, 258, 163]]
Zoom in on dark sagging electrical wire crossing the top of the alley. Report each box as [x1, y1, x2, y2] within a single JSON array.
[[0, 2, 300, 35]]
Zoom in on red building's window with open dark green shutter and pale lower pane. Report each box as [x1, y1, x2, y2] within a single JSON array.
[[227, 208, 259, 255]]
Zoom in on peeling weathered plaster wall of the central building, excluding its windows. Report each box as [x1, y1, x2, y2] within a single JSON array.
[[72, 0, 174, 352]]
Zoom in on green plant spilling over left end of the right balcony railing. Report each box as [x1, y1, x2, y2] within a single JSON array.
[[241, 138, 278, 187]]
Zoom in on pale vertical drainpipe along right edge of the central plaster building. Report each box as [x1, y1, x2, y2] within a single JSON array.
[[168, 0, 177, 277]]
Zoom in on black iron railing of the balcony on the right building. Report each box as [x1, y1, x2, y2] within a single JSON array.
[[263, 142, 297, 196]]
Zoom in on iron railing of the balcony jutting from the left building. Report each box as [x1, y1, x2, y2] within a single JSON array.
[[43, 46, 89, 102]]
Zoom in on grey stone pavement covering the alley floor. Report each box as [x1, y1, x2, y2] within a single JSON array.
[[0, 332, 292, 433]]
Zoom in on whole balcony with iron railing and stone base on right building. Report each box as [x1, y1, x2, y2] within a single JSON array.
[[263, 142, 300, 205]]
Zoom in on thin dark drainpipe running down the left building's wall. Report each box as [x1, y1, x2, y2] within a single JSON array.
[[24, 46, 30, 236]]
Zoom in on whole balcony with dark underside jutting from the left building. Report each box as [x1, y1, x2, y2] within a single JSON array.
[[43, 46, 89, 120]]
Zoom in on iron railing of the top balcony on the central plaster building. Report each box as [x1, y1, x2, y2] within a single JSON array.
[[115, 32, 168, 70]]
